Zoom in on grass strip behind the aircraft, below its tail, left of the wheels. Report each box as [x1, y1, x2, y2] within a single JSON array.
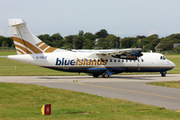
[[0, 58, 87, 76]]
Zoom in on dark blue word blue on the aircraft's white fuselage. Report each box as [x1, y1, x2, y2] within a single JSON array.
[[56, 58, 76, 65]]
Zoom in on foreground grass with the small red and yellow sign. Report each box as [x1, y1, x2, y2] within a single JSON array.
[[0, 83, 180, 120]]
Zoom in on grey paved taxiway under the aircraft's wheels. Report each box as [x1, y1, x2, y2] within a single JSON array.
[[0, 74, 180, 111]]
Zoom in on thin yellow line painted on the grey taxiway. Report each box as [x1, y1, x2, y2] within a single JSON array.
[[73, 80, 180, 100]]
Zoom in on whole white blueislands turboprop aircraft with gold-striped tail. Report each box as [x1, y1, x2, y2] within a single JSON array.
[[8, 19, 175, 78]]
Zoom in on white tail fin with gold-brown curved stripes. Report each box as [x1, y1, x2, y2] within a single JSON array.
[[8, 19, 66, 55]]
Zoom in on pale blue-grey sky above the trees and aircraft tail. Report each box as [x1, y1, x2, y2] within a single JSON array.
[[0, 0, 180, 38]]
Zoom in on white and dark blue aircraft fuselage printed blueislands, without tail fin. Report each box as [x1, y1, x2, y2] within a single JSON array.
[[8, 51, 175, 74]]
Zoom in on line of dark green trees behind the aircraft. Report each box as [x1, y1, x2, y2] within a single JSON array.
[[0, 29, 180, 51]]
